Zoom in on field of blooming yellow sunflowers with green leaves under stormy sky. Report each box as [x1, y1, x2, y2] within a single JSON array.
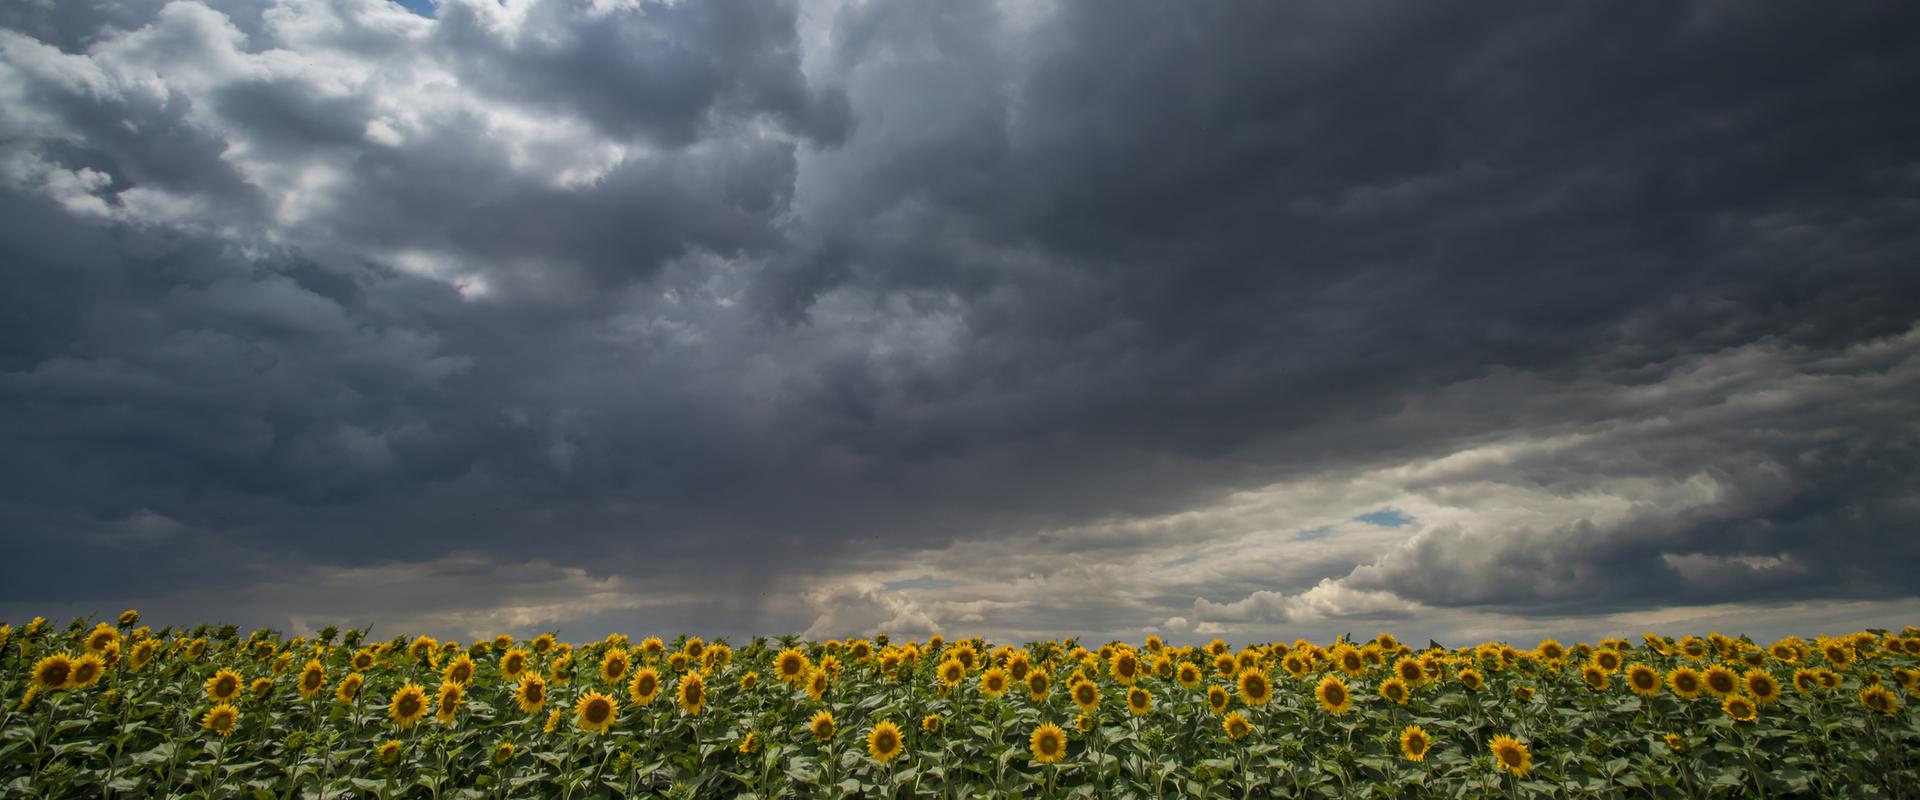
[[0, 612, 1920, 800]]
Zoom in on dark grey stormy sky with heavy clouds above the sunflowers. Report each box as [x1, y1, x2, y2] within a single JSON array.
[[0, 0, 1920, 643]]
